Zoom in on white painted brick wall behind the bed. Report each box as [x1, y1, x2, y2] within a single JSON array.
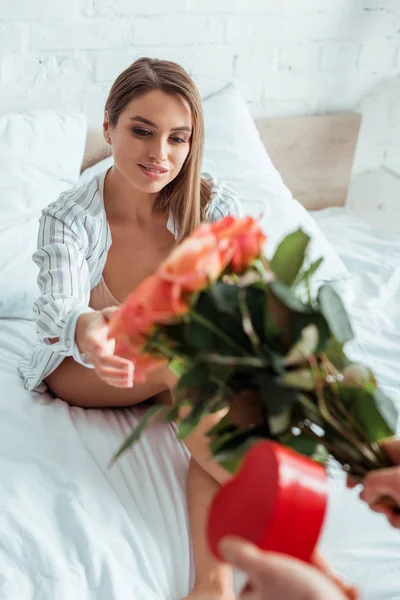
[[0, 0, 400, 172]]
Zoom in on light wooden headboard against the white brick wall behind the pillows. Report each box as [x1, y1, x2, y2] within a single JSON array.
[[82, 113, 361, 210]]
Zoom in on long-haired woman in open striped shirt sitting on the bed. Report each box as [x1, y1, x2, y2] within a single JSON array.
[[20, 58, 240, 600]]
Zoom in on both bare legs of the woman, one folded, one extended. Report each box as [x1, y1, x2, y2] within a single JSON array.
[[46, 357, 234, 600]]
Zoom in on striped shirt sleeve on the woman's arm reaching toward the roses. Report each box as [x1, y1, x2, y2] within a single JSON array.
[[33, 201, 93, 366]]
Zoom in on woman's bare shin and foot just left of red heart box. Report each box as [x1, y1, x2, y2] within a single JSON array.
[[186, 458, 234, 600]]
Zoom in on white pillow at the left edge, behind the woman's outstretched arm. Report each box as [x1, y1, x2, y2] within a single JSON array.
[[0, 110, 87, 319]]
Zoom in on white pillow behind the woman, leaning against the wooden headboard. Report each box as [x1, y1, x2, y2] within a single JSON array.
[[80, 84, 349, 282]]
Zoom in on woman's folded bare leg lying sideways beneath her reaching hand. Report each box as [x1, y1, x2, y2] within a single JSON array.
[[46, 356, 177, 408]]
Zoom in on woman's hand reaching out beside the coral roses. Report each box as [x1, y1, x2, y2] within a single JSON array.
[[75, 307, 135, 388]]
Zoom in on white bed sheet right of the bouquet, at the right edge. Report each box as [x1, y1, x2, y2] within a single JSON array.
[[312, 208, 400, 600]]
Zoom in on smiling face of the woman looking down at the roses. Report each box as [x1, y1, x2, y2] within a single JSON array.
[[104, 90, 192, 193]]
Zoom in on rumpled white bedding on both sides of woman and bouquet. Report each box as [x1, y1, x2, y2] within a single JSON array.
[[0, 204, 400, 600]]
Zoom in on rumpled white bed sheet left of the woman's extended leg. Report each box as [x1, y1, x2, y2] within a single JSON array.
[[0, 320, 192, 600]]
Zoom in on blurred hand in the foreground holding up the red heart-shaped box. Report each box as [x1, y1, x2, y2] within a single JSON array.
[[220, 538, 356, 600]]
